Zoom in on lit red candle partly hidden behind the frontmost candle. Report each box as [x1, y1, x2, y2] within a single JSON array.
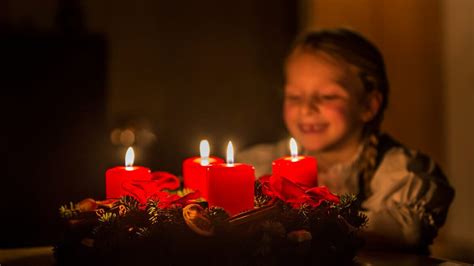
[[183, 140, 224, 198]]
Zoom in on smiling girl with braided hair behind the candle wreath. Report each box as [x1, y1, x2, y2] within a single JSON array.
[[240, 29, 454, 252]]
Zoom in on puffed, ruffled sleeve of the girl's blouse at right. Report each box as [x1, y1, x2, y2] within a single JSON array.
[[362, 147, 454, 251]]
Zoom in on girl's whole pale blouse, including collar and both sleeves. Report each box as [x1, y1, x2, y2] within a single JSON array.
[[238, 139, 454, 252]]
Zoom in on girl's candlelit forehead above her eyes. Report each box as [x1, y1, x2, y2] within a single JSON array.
[[285, 50, 361, 91]]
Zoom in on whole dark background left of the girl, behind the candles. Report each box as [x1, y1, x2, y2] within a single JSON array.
[[0, 0, 297, 247]]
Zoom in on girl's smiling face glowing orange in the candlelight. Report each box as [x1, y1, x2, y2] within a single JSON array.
[[283, 50, 373, 152]]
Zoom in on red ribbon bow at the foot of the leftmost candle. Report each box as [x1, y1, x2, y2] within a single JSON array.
[[122, 172, 179, 204]]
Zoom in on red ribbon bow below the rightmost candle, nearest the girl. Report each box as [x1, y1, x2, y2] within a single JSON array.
[[259, 175, 339, 208]]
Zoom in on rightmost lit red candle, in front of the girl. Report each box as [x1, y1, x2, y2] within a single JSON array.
[[272, 138, 318, 188]]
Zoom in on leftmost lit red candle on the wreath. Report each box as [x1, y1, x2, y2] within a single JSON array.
[[105, 147, 151, 199]]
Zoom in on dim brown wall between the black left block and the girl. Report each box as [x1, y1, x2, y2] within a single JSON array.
[[100, 1, 297, 174]]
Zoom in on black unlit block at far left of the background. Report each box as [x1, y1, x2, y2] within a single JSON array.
[[0, 31, 107, 246]]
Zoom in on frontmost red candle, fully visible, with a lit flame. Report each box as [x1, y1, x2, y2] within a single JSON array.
[[208, 142, 255, 215]]
